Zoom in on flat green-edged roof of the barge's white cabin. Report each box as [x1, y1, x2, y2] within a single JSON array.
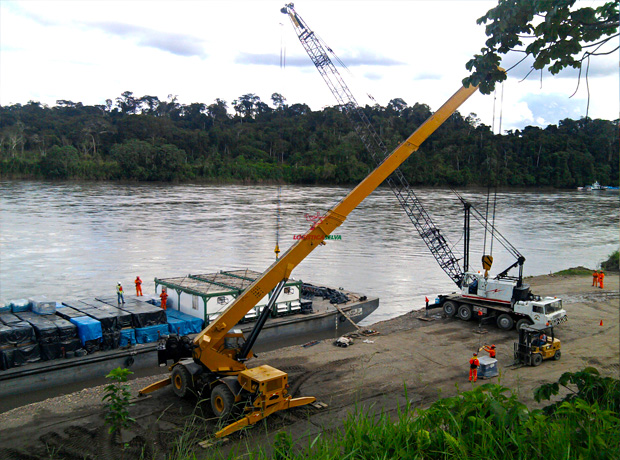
[[155, 269, 299, 296]]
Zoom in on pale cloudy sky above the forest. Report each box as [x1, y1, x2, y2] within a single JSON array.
[[0, 0, 619, 132]]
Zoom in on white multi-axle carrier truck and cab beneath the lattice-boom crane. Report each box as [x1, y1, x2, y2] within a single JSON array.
[[436, 272, 568, 330]]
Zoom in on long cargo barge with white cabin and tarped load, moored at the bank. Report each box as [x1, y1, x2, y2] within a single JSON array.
[[0, 270, 379, 397]]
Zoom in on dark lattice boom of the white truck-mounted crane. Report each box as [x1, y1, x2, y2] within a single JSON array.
[[281, 3, 463, 286]]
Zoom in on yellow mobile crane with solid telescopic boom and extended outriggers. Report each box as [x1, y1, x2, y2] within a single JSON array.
[[140, 34, 477, 444]]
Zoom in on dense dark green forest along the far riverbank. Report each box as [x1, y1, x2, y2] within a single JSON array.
[[0, 91, 620, 188]]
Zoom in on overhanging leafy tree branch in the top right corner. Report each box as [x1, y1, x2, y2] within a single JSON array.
[[463, 0, 618, 94]]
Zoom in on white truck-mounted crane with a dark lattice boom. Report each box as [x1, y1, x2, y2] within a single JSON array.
[[280, 3, 567, 330]]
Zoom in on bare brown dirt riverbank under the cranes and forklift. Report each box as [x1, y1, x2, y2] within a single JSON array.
[[0, 274, 620, 459]]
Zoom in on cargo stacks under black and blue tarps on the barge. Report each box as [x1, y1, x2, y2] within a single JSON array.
[[0, 296, 203, 370]]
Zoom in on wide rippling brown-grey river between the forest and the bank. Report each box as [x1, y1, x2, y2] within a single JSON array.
[[0, 181, 619, 323]]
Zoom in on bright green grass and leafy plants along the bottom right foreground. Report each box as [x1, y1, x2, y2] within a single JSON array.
[[209, 368, 620, 460]]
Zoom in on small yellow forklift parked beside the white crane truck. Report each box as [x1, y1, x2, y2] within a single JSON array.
[[515, 325, 562, 366]]
